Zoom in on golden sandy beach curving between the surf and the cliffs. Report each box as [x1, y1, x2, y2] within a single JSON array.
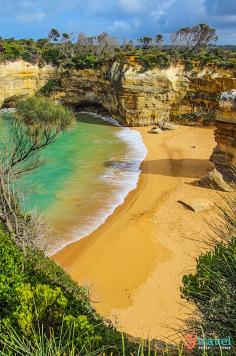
[[53, 126, 225, 341]]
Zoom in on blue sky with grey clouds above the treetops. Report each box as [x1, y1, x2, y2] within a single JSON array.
[[0, 0, 236, 45]]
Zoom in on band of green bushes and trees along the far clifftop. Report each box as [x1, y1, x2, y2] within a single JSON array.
[[0, 24, 236, 70]]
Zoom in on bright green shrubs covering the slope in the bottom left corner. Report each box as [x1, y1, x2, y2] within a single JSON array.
[[0, 227, 138, 355]]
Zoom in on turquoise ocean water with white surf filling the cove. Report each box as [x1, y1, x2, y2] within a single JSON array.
[[0, 113, 146, 255]]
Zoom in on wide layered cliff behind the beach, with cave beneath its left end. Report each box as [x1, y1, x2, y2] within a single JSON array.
[[57, 62, 236, 126]]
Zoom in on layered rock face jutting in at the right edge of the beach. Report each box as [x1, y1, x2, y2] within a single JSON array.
[[211, 90, 236, 181]]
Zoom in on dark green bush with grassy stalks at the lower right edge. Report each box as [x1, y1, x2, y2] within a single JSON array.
[[182, 195, 236, 340]]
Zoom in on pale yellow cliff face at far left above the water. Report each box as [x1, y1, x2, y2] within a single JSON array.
[[0, 60, 55, 107]]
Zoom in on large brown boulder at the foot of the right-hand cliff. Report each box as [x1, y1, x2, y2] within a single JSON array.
[[198, 169, 232, 192]]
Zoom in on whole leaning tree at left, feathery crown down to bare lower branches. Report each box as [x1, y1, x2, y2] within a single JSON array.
[[0, 96, 75, 250]]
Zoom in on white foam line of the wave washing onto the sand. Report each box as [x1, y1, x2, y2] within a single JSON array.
[[48, 112, 147, 255]]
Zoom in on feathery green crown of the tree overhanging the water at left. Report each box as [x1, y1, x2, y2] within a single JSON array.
[[0, 96, 75, 177]]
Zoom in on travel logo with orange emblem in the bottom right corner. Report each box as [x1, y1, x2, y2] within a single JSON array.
[[184, 334, 232, 351]]
